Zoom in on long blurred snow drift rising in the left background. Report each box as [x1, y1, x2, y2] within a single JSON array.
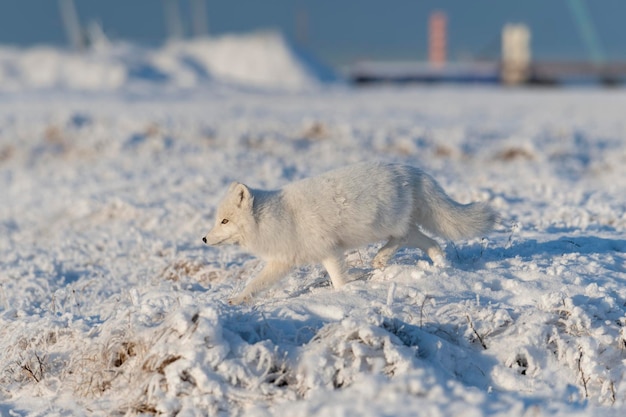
[[0, 31, 333, 92]]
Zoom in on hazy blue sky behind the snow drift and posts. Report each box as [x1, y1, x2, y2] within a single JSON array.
[[0, 0, 626, 65]]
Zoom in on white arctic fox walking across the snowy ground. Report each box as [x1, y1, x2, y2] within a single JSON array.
[[202, 162, 498, 304]]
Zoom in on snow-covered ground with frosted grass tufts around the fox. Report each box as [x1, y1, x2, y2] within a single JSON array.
[[0, 36, 626, 416]]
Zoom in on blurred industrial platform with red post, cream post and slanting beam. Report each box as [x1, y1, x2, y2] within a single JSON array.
[[349, 0, 626, 85]]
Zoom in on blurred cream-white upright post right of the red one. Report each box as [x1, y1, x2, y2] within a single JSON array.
[[501, 23, 531, 85]]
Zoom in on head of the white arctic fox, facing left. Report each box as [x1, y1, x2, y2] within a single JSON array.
[[202, 182, 254, 246]]
